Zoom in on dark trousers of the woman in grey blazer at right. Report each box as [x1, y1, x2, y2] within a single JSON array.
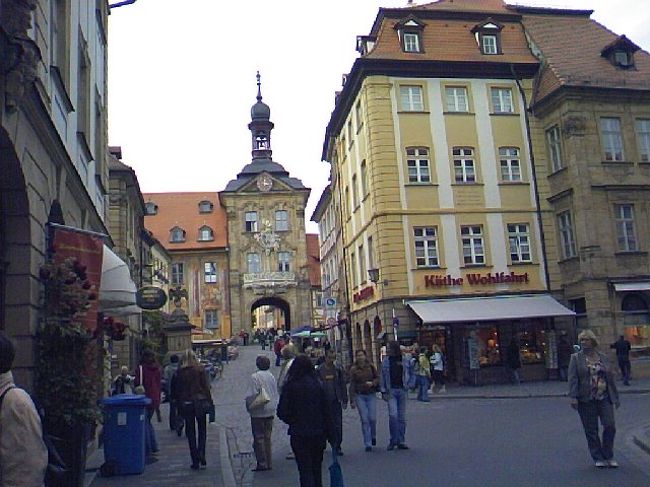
[[578, 398, 616, 461]]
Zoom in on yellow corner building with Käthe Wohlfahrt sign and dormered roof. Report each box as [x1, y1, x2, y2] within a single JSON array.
[[323, 2, 573, 382]]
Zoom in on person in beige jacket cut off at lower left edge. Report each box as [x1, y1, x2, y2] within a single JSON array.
[[0, 332, 48, 487]]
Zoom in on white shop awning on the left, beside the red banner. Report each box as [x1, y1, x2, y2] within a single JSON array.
[[99, 245, 136, 311]]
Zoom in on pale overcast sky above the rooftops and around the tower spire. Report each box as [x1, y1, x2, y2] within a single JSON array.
[[108, 0, 650, 232]]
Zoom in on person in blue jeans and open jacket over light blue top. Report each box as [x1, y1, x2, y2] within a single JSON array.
[[379, 340, 413, 451]]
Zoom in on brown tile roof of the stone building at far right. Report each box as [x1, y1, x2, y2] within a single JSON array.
[[523, 9, 650, 101]]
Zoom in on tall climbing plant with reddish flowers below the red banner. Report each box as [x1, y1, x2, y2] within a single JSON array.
[[36, 258, 102, 487]]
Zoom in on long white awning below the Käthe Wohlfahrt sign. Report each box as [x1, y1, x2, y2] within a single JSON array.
[[406, 294, 575, 323]]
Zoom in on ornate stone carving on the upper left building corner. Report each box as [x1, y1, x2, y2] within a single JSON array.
[[0, 0, 41, 111]]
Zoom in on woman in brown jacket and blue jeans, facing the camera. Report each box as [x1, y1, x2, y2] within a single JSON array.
[[349, 350, 379, 452]]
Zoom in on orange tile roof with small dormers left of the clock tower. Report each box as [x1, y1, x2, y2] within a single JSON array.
[[143, 192, 228, 252]]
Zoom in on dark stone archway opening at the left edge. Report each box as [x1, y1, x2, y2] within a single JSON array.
[[0, 128, 31, 337]]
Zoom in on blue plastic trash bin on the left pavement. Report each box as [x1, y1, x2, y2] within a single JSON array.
[[102, 394, 151, 475]]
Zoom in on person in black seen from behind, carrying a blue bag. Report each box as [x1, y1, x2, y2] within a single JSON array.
[[278, 355, 333, 487]]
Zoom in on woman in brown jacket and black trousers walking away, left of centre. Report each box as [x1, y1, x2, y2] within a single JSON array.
[[173, 350, 214, 470]]
